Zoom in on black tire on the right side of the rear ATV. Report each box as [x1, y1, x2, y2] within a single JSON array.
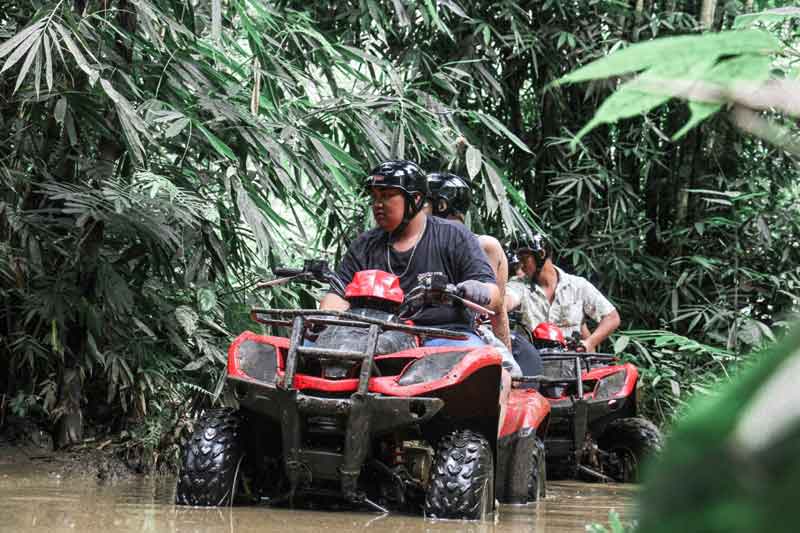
[[598, 418, 663, 483]]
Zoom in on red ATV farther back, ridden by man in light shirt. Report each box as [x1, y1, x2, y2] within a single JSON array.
[[531, 322, 662, 482]]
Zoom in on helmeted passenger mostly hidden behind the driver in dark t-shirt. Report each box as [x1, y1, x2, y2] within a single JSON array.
[[424, 172, 542, 375]]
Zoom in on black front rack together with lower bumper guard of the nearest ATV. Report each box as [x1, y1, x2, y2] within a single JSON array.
[[244, 309, 467, 502]]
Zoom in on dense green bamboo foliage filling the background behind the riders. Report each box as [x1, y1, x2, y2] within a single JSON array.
[[0, 0, 800, 466]]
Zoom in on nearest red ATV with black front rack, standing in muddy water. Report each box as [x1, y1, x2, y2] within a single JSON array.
[[176, 261, 550, 519]]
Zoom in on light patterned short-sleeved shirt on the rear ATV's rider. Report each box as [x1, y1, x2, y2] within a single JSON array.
[[506, 267, 615, 337]]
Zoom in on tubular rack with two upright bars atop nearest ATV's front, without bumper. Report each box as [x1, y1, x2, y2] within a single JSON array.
[[250, 309, 467, 395]]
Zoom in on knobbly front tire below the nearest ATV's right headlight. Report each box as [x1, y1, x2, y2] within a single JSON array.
[[423, 429, 494, 520]]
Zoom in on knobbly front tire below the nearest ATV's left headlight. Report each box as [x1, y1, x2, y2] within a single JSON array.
[[175, 409, 243, 507]]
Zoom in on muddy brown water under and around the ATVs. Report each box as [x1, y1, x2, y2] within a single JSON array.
[[0, 460, 636, 533]]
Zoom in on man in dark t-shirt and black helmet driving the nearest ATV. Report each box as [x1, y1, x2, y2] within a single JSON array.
[[320, 161, 503, 346]]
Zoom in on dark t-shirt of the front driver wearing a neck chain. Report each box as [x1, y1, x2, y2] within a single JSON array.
[[336, 217, 496, 326]]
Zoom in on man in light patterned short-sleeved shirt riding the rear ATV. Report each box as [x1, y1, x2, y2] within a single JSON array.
[[506, 234, 620, 352]]
